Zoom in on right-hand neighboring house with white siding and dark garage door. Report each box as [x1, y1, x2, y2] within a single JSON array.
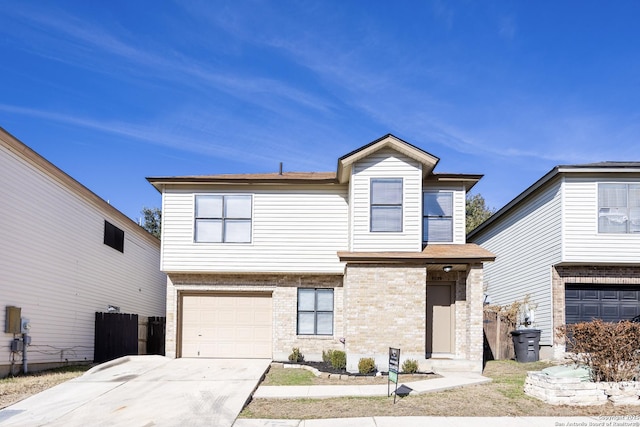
[[467, 162, 640, 357]]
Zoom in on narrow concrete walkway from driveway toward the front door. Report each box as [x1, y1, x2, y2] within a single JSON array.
[[253, 372, 491, 399]]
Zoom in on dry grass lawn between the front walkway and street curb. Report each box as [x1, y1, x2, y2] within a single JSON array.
[[240, 361, 640, 419]]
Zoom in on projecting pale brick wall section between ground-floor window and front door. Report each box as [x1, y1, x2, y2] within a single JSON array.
[[344, 264, 427, 372]]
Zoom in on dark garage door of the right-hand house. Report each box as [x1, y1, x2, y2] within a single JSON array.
[[565, 284, 640, 323]]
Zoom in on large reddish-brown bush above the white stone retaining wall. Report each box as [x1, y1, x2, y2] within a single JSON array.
[[557, 319, 640, 382]]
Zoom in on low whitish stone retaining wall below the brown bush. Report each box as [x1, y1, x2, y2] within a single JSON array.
[[524, 372, 640, 406]]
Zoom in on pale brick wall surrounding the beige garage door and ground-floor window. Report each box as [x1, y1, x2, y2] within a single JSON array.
[[166, 274, 344, 361]]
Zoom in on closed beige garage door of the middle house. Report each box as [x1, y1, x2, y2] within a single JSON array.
[[181, 294, 273, 359]]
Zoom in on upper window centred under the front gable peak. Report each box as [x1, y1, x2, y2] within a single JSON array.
[[371, 178, 402, 232]]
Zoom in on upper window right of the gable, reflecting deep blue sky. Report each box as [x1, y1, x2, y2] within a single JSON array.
[[422, 191, 453, 244]]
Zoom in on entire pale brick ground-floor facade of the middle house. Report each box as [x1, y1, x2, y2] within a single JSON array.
[[166, 264, 483, 372]]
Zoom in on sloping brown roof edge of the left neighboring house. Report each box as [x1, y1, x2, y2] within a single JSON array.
[[0, 127, 160, 246]]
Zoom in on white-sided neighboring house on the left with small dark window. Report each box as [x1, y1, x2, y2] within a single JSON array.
[[0, 128, 166, 375]]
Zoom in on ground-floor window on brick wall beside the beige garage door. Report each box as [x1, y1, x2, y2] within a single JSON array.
[[298, 288, 333, 335]]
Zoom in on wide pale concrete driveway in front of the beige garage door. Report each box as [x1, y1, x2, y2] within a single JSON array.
[[0, 356, 271, 427]]
